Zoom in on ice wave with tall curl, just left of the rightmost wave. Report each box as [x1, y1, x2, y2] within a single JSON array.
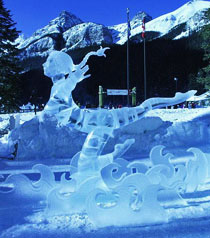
[[145, 145, 187, 206]]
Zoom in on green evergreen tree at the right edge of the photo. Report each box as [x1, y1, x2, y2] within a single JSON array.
[[198, 10, 210, 90]]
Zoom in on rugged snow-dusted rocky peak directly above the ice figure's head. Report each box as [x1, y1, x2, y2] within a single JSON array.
[[19, 11, 113, 61]]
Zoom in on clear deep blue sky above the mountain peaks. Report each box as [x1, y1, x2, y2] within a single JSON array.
[[4, 0, 203, 37]]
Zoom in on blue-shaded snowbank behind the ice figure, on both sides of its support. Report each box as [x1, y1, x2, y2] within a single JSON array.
[[0, 108, 210, 160]]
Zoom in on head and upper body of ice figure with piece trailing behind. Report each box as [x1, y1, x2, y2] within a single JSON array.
[[43, 48, 108, 115]]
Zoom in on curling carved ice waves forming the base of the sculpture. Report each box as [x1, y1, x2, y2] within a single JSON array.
[[0, 143, 208, 227]]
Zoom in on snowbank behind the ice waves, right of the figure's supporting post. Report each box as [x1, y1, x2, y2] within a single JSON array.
[[105, 108, 210, 158]]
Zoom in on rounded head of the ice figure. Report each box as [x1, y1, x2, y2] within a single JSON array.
[[43, 51, 75, 80]]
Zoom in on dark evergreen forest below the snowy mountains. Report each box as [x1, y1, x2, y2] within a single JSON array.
[[0, 0, 210, 112]]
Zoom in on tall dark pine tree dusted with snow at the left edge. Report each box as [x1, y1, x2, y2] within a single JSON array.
[[0, 0, 21, 112]]
